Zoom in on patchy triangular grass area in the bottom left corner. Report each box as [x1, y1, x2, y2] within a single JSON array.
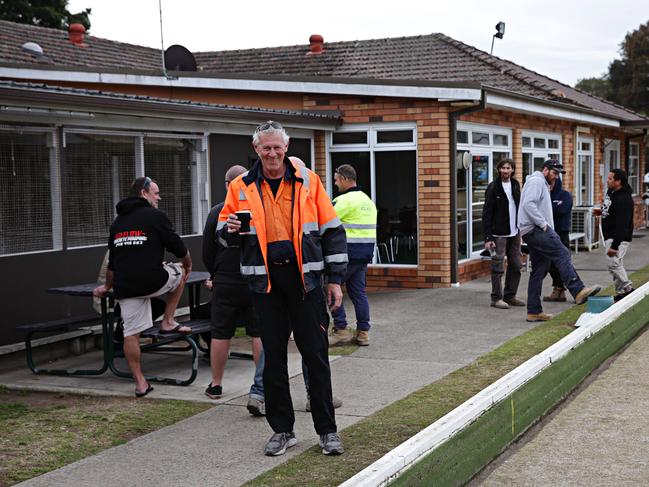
[[0, 386, 212, 486]]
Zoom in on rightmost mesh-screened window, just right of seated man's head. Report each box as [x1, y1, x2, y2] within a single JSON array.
[[144, 137, 198, 235]]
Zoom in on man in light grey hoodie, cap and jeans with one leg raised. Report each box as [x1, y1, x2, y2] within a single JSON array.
[[518, 159, 601, 321]]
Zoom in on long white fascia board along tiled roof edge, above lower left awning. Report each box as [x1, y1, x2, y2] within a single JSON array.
[[0, 68, 482, 101]]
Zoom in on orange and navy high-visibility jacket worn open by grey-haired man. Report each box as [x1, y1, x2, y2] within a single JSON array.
[[217, 158, 348, 293]]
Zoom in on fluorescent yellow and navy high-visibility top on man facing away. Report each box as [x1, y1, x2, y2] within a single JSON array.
[[333, 186, 377, 264]]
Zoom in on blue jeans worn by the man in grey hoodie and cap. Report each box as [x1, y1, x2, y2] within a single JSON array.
[[523, 227, 584, 314]]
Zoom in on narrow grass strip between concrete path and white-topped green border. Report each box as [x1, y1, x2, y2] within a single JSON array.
[[245, 266, 649, 487]]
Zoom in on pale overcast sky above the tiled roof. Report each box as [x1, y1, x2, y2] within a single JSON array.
[[68, 0, 649, 86]]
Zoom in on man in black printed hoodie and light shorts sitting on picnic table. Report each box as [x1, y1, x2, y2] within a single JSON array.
[[93, 177, 192, 397]]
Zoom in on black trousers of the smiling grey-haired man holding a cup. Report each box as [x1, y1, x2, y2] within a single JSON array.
[[253, 264, 337, 435]]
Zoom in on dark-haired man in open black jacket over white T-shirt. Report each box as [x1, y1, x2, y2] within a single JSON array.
[[482, 159, 525, 309]]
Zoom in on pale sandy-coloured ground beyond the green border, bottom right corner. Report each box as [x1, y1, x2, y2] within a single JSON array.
[[474, 324, 649, 487]]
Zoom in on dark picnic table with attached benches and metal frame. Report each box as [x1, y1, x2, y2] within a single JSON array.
[[18, 271, 210, 385]]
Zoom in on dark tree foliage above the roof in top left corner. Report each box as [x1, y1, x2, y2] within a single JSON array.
[[0, 0, 91, 30]]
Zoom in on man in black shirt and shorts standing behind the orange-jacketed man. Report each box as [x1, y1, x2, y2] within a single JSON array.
[[203, 166, 264, 416]]
